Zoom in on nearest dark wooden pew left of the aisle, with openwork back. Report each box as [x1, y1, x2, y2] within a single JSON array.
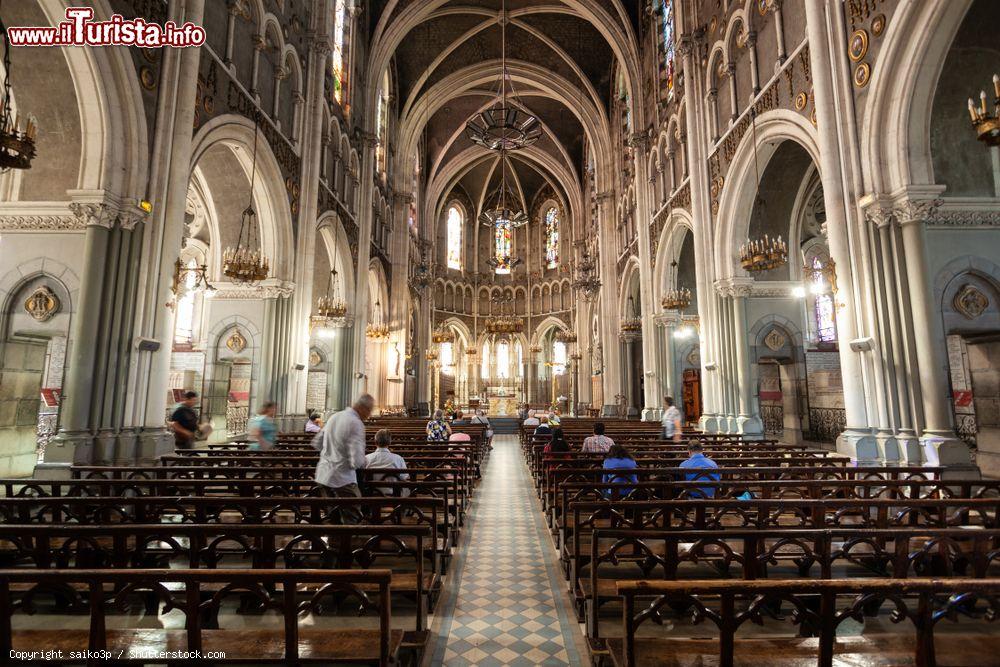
[[0, 569, 403, 667]]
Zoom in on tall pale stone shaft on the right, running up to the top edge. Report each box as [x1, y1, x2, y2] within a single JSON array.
[[805, 0, 874, 458]]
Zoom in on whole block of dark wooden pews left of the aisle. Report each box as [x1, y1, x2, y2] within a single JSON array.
[[0, 419, 489, 665]]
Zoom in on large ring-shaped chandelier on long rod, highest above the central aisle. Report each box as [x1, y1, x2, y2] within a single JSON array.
[[465, 1, 542, 151]]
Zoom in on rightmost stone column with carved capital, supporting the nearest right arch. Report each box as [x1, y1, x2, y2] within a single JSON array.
[[896, 193, 969, 465]]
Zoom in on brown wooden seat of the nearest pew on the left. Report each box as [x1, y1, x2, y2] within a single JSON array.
[[12, 628, 404, 665]]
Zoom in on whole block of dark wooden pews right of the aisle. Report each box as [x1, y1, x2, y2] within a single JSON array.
[[521, 420, 1000, 667]]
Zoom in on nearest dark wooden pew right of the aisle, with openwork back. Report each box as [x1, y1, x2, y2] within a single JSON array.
[[608, 579, 1000, 667]]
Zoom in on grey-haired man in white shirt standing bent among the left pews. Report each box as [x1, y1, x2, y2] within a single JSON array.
[[313, 394, 375, 497]]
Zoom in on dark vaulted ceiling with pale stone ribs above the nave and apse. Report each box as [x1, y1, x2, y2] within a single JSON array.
[[369, 0, 642, 227]]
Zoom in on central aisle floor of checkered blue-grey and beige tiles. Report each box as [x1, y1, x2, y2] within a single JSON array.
[[424, 435, 586, 667]]
